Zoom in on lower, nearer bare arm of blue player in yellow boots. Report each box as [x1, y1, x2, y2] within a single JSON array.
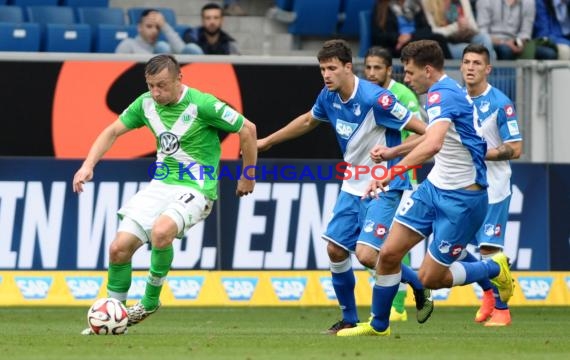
[[363, 121, 451, 198]]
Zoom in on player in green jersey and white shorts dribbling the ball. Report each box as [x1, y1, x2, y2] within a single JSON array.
[[73, 55, 257, 334]]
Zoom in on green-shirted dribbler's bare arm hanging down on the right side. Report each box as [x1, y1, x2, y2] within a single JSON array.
[[236, 118, 257, 196]]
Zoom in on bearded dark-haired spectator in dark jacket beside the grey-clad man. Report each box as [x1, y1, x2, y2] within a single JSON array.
[[183, 3, 240, 55]]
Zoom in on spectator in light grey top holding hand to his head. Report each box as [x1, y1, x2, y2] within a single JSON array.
[[115, 9, 202, 54]]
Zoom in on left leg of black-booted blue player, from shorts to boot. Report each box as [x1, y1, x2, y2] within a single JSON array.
[[322, 191, 365, 334]]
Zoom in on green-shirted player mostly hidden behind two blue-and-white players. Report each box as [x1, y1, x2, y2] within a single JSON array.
[[364, 46, 421, 321]]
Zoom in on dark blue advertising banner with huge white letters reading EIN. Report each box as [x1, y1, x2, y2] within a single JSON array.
[[0, 158, 556, 271]]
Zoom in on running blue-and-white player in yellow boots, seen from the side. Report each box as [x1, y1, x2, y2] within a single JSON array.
[[337, 40, 513, 336]]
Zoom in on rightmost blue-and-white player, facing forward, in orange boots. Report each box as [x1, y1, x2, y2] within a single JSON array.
[[461, 44, 522, 326]]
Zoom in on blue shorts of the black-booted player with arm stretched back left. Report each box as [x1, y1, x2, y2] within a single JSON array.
[[323, 190, 402, 252]]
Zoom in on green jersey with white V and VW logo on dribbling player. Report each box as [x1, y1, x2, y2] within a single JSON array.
[[119, 86, 244, 200]]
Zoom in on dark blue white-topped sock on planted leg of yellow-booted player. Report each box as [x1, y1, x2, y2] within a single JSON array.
[[370, 273, 402, 331]]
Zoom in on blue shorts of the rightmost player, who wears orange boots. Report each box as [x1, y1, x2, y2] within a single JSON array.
[[473, 195, 511, 249]]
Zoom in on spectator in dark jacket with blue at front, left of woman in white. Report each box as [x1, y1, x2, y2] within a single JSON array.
[[371, 0, 451, 59]]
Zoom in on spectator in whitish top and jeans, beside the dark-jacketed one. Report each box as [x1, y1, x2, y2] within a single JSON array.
[[421, 0, 497, 59]]
